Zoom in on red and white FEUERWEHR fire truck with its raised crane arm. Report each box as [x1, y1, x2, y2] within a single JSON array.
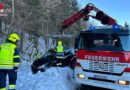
[[61, 3, 130, 90]]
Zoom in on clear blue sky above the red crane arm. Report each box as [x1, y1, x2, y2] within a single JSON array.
[[77, 0, 130, 25]]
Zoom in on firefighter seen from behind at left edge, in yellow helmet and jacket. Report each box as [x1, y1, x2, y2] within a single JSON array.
[[0, 33, 20, 90]]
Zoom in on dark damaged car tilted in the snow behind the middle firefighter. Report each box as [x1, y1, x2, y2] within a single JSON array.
[[31, 48, 76, 74]]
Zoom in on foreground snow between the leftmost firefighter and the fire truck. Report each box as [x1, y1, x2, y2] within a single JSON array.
[[16, 67, 75, 90]]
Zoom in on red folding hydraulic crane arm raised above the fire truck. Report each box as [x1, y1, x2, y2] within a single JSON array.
[[62, 3, 117, 31]]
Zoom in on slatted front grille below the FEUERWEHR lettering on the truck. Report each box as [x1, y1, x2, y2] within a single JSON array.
[[89, 60, 114, 72]]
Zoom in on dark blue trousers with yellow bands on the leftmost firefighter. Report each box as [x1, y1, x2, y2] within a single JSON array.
[[0, 69, 17, 90]]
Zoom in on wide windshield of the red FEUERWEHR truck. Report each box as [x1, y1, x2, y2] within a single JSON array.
[[78, 33, 130, 51]]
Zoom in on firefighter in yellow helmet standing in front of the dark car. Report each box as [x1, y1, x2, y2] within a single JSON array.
[[55, 41, 64, 66]]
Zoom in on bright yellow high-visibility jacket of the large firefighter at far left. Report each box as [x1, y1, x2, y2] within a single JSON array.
[[0, 43, 20, 69]]
